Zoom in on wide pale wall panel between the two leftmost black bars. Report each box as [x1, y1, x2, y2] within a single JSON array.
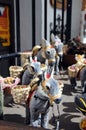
[[20, 0, 32, 51]]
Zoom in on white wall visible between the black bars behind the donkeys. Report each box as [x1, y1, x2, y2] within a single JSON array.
[[20, 0, 81, 51]]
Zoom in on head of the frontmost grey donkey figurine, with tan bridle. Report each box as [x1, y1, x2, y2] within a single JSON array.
[[38, 78, 63, 104]]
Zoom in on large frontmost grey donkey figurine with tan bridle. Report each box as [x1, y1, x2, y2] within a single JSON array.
[[26, 77, 62, 129]]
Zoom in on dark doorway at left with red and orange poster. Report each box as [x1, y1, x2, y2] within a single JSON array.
[[0, 0, 15, 77]]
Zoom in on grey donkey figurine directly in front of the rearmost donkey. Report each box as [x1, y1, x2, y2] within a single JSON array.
[[32, 39, 56, 77]]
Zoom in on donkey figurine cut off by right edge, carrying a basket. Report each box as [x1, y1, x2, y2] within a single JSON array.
[[68, 54, 86, 93]]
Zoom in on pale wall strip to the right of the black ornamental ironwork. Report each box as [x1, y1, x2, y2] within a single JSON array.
[[71, 0, 82, 38]]
